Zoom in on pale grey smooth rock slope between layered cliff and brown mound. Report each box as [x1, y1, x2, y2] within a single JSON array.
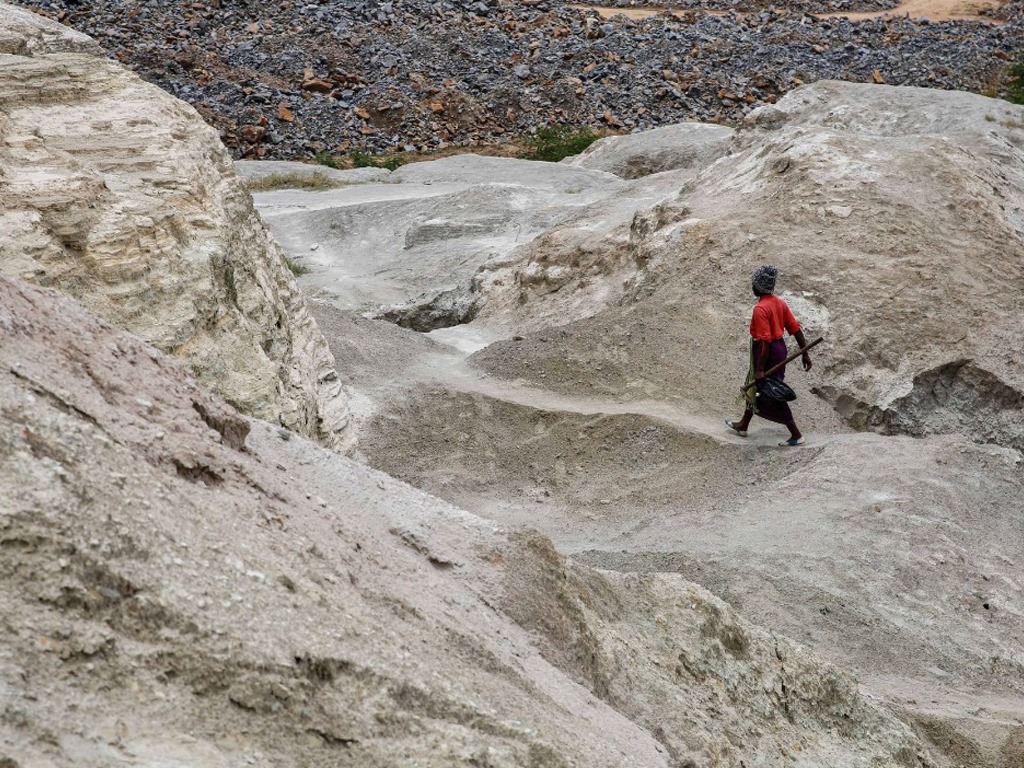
[[250, 155, 626, 331]]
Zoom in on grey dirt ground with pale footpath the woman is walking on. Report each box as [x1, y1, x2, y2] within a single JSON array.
[[314, 282, 1024, 766]]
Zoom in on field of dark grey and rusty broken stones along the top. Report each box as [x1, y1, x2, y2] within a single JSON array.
[[9, 0, 1024, 159]]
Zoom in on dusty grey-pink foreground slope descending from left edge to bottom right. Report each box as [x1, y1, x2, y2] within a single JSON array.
[[0, 279, 931, 768]]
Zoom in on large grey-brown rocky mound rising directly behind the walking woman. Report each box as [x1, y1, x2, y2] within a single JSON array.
[[468, 82, 1024, 449]]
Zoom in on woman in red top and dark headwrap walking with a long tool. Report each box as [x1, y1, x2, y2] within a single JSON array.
[[725, 264, 811, 445]]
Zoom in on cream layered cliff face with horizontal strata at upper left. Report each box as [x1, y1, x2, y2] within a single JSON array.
[[0, 1, 350, 450]]
